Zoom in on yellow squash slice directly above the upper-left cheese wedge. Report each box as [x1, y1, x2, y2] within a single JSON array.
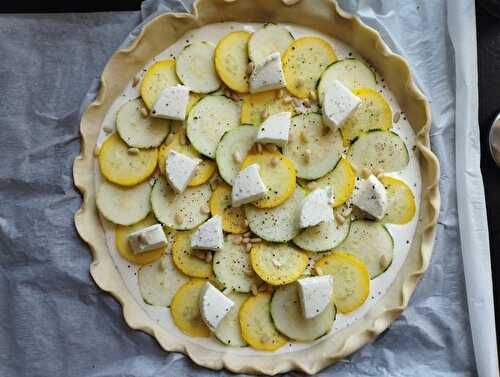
[[141, 60, 180, 110]]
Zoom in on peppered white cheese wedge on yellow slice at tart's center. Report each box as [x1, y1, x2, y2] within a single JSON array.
[[231, 164, 267, 207]]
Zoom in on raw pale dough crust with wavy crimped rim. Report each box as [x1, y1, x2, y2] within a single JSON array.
[[73, 0, 440, 375]]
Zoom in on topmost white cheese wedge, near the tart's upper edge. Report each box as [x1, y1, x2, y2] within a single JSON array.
[[249, 52, 285, 93]]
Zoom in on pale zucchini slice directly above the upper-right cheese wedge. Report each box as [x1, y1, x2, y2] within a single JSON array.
[[318, 58, 377, 104]]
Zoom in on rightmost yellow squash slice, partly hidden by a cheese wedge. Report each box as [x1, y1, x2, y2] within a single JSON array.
[[381, 176, 416, 224]]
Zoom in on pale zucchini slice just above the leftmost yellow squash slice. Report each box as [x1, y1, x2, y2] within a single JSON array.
[[116, 98, 170, 148]]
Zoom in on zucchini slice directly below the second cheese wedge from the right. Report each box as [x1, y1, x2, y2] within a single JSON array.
[[293, 209, 350, 253]]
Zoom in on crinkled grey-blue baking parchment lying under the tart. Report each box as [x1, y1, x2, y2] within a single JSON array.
[[0, 0, 475, 376]]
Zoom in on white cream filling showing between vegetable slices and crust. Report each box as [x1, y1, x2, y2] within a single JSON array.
[[95, 22, 421, 357]]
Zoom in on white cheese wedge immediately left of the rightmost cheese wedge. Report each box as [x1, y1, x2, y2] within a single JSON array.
[[299, 186, 333, 228]]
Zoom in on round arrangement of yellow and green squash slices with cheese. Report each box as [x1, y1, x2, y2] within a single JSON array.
[[96, 24, 417, 351]]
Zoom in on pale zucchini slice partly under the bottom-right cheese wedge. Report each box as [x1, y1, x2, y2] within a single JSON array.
[[271, 283, 336, 342]]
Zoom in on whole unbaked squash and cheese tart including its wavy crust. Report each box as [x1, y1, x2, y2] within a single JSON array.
[[74, 0, 439, 374]]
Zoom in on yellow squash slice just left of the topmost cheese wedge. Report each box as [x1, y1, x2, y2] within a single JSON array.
[[215, 31, 252, 93]]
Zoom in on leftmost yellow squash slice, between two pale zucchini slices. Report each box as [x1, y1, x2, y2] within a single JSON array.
[[99, 134, 158, 186]]
